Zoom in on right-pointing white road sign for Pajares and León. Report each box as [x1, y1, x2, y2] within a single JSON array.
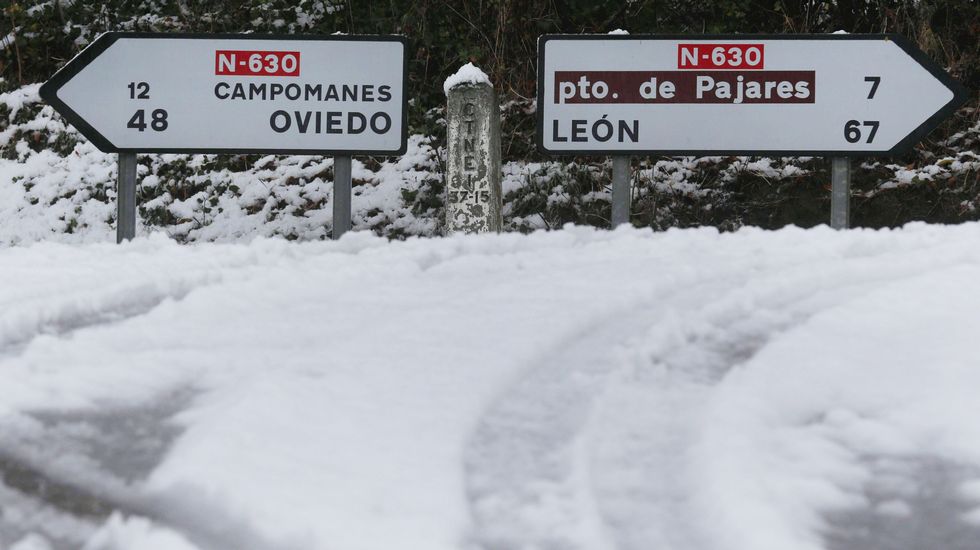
[[538, 34, 967, 156]]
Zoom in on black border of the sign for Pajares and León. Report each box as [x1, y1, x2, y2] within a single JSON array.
[[535, 33, 969, 157]]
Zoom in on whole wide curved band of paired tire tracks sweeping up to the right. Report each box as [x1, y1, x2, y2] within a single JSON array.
[[465, 244, 980, 550]]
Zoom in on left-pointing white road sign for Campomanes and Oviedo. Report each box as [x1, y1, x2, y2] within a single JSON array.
[[41, 33, 407, 154]]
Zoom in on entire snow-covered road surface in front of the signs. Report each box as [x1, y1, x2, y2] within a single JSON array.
[[0, 224, 980, 550]]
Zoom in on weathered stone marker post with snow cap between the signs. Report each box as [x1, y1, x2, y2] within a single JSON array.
[[443, 63, 503, 234]]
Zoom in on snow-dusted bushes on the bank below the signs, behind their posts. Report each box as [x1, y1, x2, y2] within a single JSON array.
[[0, 84, 980, 245]]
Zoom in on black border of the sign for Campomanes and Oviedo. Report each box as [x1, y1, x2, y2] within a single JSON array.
[[40, 31, 409, 156]]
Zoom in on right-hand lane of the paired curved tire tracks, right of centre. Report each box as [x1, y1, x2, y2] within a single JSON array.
[[580, 305, 802, 550]]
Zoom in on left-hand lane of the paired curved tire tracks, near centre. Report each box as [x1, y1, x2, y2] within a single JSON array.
[[465, 276, 740, 550]]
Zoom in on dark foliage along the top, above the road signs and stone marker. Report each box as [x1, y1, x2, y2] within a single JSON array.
[[0, 0, 980, 120]]
